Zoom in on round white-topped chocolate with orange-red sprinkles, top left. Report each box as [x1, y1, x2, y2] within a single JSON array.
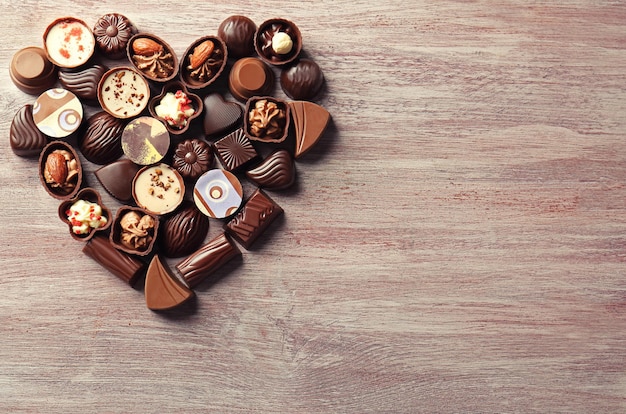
[[43, 17, 96, 68]]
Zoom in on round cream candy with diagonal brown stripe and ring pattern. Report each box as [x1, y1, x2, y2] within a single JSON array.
[[33, 88, 83, 138]]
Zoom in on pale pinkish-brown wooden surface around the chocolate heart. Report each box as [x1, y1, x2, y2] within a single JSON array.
[[0, 0, 626, 413]]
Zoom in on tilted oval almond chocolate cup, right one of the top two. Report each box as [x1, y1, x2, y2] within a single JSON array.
[[179, 36, 228, 90]]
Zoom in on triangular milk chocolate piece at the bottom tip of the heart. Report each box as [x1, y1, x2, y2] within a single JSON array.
[[144, 255, 194, 311]]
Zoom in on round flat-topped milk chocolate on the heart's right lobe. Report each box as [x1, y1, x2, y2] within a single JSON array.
[[228, 57, 275, 101]]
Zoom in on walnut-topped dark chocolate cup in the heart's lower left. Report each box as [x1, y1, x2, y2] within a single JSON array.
[[109, 206, 159, 256]]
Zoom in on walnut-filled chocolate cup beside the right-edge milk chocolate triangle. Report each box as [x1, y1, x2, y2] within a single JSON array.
[[243, 96, 291, 144]]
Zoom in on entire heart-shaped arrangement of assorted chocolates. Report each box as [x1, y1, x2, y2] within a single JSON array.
[[10, 13, 330, 310]]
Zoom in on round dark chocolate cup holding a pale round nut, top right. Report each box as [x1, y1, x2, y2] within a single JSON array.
[[254, 18, 302, 66]]
